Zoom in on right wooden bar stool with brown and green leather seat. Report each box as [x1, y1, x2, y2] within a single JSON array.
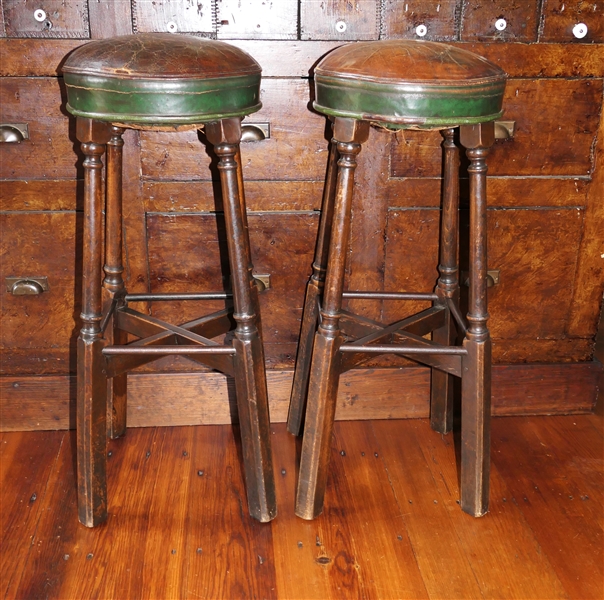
[[288, 40, 506, 519]]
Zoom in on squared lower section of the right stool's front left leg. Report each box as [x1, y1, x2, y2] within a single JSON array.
[[296, 331, 341, 520]]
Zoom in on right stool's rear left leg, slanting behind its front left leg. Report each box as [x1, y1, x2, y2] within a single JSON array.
[[287, 127, 338, 435]]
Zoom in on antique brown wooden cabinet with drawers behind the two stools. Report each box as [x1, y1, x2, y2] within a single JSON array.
[[0, 0, 604, 429]]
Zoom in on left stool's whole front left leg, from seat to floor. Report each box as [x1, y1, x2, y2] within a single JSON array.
[[77, 118, 110, 527]]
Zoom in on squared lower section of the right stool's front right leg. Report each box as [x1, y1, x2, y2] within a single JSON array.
[[461, 339, 491, 517]]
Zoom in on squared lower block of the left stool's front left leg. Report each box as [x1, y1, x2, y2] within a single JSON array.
[[77, 338, 107, 527]]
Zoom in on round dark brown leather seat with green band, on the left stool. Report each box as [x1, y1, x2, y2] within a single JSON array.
[[63, 33, 262, 126]]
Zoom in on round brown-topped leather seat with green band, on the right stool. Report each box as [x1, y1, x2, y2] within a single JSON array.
[[313, 40, 506, 129]]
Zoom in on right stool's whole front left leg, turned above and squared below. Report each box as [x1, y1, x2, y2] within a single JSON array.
[[296, 117, 369, 519]]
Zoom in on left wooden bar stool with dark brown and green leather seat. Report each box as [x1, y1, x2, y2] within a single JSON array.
[[63, 34, 277, 527]]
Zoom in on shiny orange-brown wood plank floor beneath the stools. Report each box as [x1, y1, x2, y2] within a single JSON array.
[[0, 411, 604, 599]]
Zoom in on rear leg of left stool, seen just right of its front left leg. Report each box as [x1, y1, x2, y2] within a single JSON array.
[[103, 127, 128, 439]]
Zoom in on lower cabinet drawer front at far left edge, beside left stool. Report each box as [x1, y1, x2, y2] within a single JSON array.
[[0, 212, 81, 373]]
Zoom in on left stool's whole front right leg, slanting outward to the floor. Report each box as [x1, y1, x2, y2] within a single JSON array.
[[205, 118, 277, 522]]
